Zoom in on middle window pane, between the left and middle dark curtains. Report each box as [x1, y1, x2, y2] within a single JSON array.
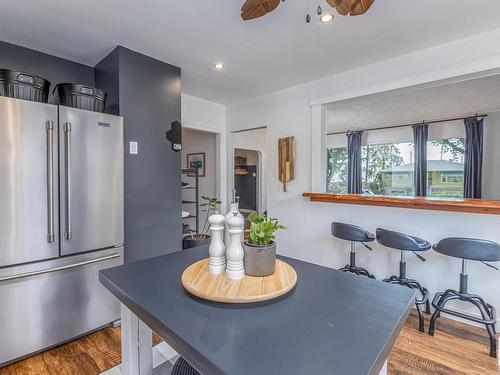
[[361, 142, 414, 196]]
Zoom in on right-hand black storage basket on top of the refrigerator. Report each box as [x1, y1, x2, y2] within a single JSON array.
[[54, 83, 106, 112]]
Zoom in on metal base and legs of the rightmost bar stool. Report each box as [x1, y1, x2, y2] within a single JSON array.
[[429, 259, 497, 358]]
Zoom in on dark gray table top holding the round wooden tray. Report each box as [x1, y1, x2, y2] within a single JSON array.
[[99, 247, 414, 375]]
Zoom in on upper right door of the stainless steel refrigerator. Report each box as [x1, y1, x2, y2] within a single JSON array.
[[59, 107, 124, 255]]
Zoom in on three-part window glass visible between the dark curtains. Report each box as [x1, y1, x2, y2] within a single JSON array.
[[326, 132, 465, 198]]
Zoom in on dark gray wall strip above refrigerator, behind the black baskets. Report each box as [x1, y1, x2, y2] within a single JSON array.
[[0, 41, 94, 103]]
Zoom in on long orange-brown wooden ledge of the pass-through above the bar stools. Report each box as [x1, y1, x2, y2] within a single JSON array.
[[302, 193, 500, 215]]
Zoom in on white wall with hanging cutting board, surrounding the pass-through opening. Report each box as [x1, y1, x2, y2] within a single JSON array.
[[226, 29, 500, 324]]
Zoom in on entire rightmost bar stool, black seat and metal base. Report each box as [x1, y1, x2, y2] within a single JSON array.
[[429, 237, 500, 357]]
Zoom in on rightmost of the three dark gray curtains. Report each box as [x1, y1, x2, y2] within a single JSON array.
[[464, 117, 483, 198]]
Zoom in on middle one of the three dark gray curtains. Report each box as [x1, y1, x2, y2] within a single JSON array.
[[413, 124, 429, 197]]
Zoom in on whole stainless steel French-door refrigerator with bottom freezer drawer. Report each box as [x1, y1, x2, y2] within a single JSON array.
[[0, 97, 124, 367]]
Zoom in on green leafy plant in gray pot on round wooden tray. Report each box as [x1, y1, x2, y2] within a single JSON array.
[[243, 213, 286, 277]]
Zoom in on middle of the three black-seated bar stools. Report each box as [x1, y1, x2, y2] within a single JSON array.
[[377, 228, 431, 332]]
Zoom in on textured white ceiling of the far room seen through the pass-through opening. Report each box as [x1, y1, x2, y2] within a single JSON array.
[[326, 75, 500, 132]]
